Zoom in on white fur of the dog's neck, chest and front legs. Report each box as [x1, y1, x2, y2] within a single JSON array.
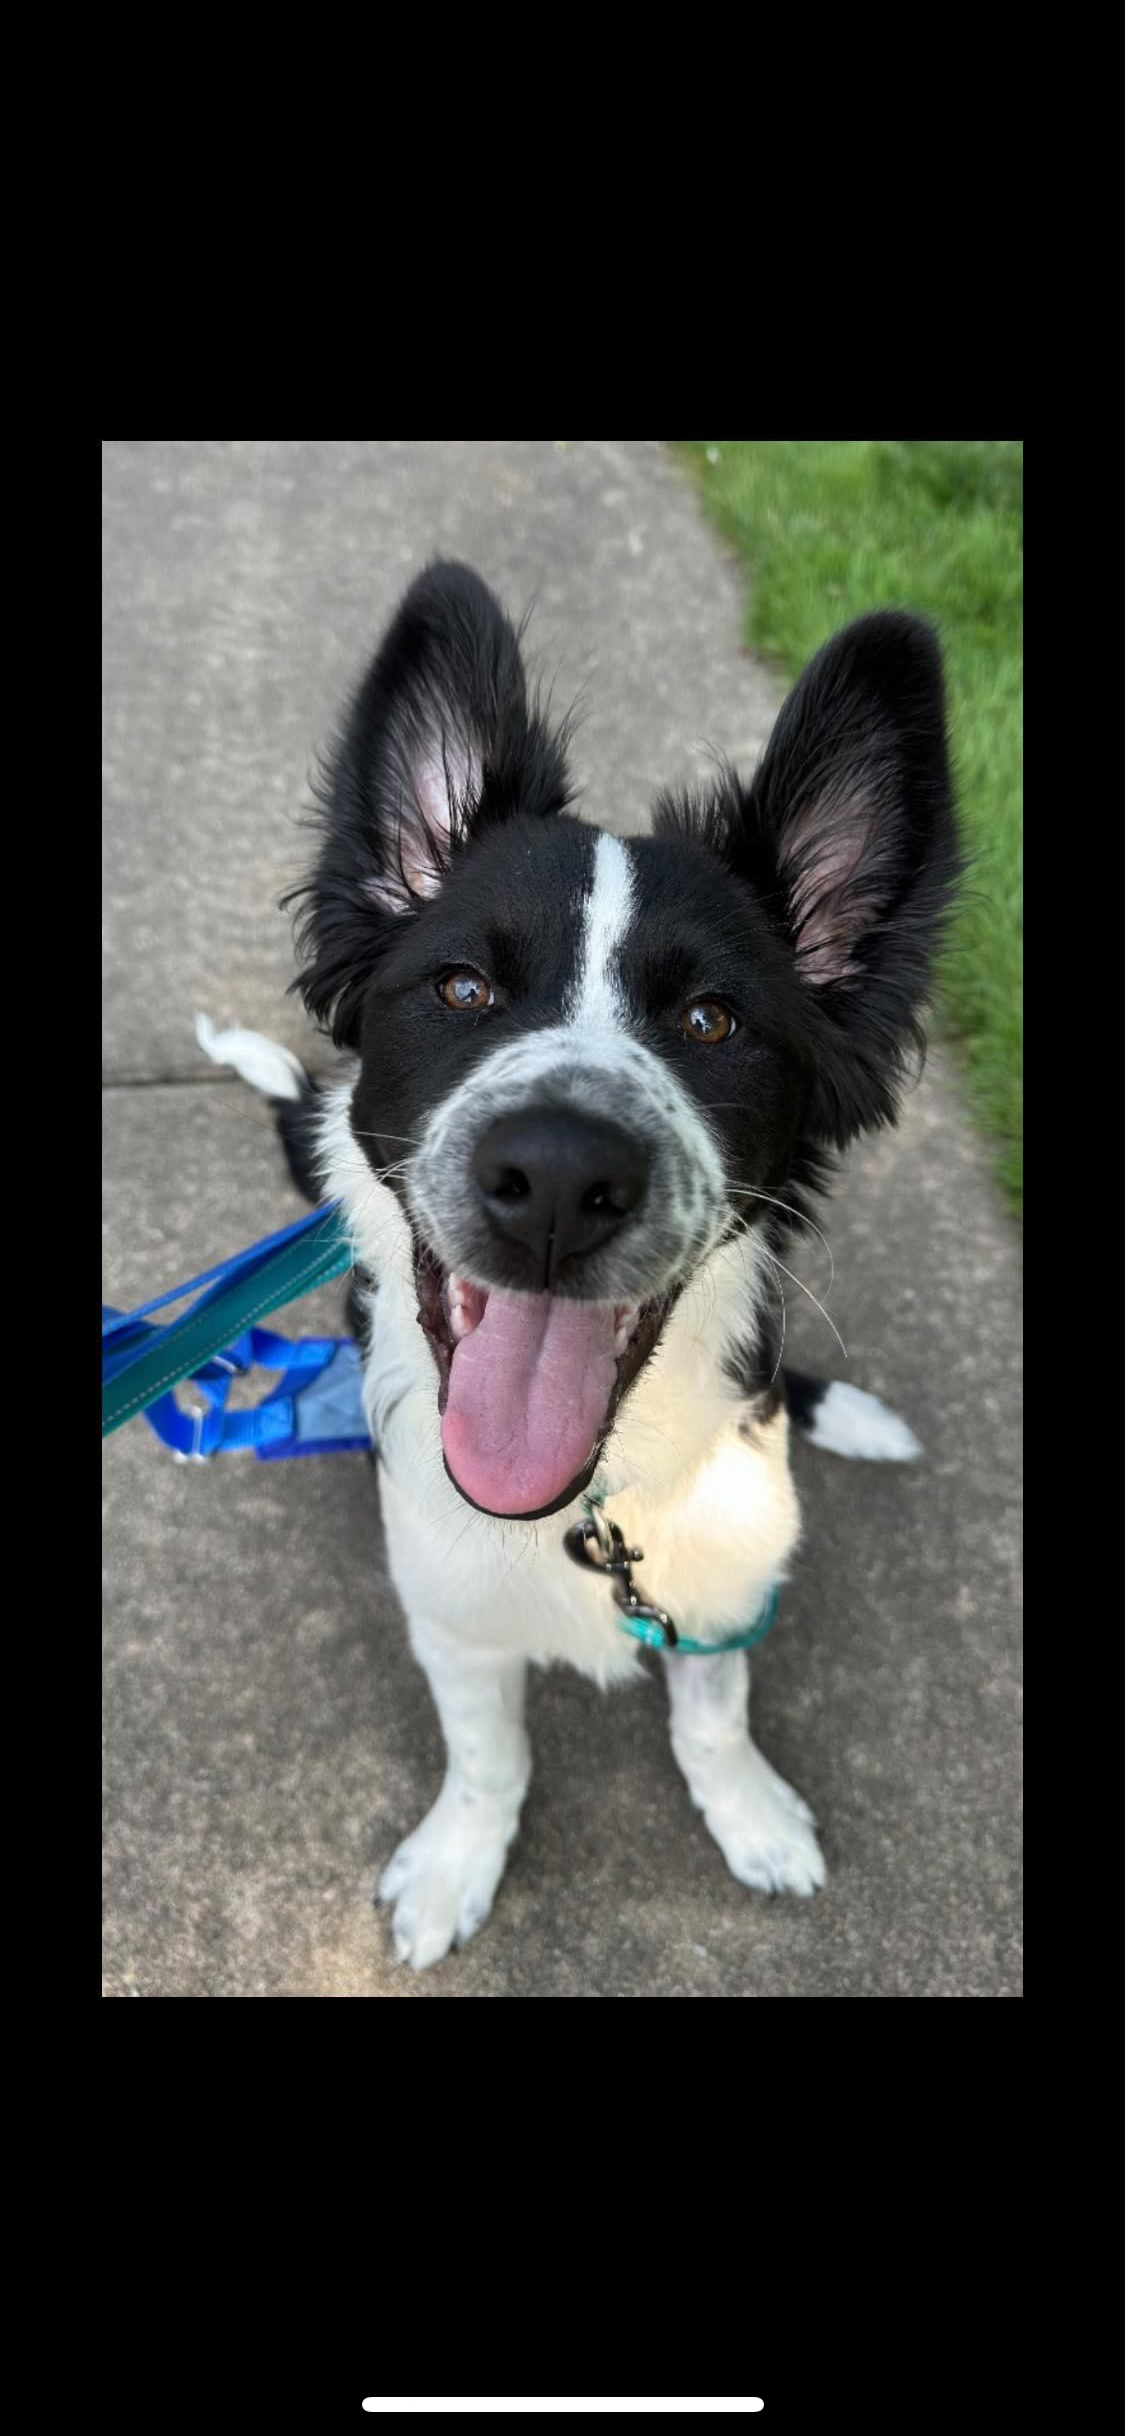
[[321, 1076, 823, 1971]]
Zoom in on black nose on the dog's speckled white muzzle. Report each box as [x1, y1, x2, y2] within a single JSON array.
[[472, 1108, 648, 1289]]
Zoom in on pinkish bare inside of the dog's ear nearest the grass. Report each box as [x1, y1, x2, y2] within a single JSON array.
[[782, 792, 884, 984]]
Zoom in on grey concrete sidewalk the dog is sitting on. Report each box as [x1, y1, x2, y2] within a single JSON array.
[[105, 441, 1020, 1995]]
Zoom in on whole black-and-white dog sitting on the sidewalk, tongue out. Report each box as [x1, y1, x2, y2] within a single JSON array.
[[204, 565, 957, 1971]]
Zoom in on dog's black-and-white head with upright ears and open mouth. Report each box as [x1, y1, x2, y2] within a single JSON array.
[[287, 565, 957, 1515]]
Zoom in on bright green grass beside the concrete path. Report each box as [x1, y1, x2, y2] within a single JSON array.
[[682, 441, 1023, 1211]]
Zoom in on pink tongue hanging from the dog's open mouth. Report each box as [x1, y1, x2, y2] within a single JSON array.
[[441, 1291, 616, 1515]]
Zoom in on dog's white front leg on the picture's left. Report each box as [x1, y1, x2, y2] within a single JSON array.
[[380, 1620, 531, 1971]]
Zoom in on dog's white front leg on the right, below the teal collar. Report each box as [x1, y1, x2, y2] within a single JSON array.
[[665, 1649, 825, 1895]]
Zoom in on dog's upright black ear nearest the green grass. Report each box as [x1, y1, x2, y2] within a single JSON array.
[[728, 611, 959, 1147]]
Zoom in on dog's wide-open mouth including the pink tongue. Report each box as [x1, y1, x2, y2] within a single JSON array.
[[414, 1237, 675, 1523]]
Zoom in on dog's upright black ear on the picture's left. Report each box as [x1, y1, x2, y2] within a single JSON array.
[[282, 560, 570, 1047]]
